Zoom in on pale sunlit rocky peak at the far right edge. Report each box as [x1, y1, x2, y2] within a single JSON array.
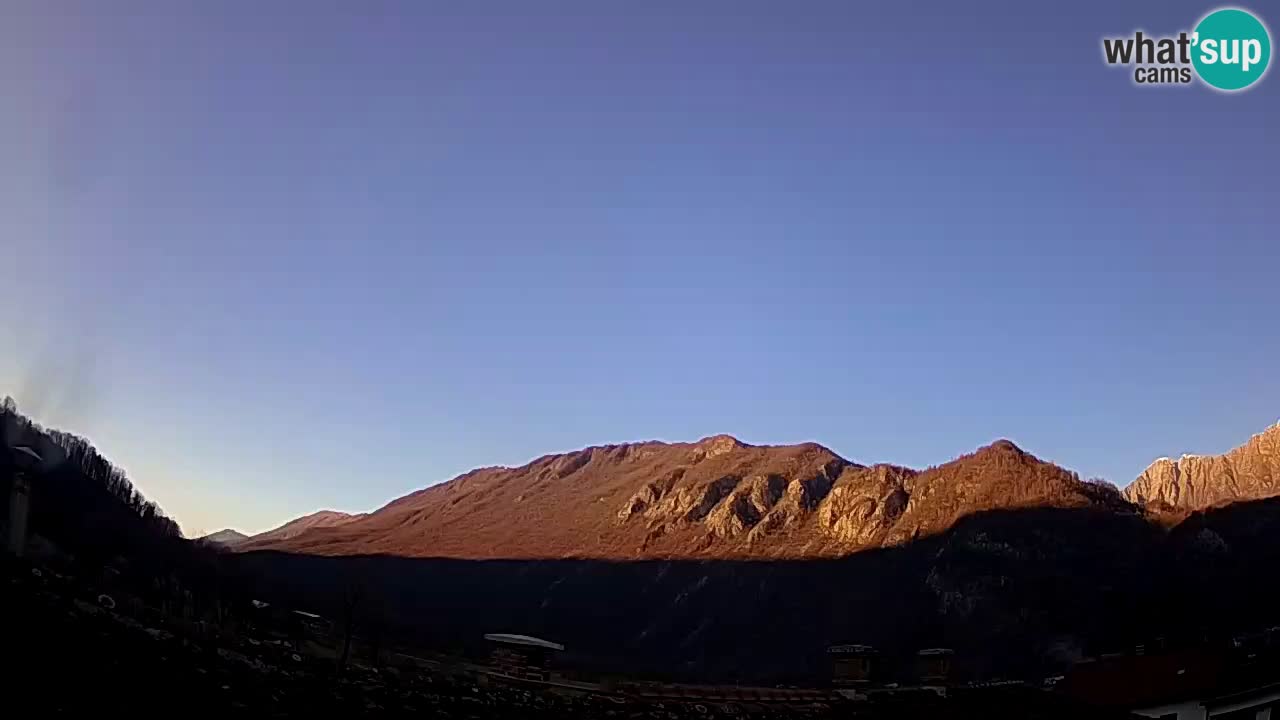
[[1125, 423, 1280, 512]]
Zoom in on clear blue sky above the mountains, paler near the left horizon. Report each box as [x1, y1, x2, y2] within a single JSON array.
[[0, 0, 1280, 536]]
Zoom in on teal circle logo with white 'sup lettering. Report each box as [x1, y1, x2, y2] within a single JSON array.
[[1192, 8, 1271, 91]]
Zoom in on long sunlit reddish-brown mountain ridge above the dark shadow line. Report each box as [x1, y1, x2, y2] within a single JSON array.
[[242, 436, 1125, 560]]
